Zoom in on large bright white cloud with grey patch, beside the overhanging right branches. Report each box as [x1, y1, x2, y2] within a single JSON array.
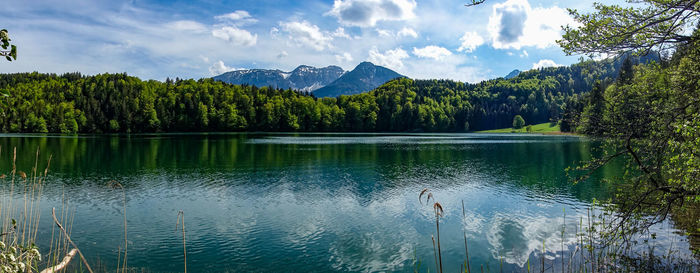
[[488, 0, 575, 49]]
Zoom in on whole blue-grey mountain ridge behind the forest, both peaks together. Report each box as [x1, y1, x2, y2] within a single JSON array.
[[213, 62, 405, 97]]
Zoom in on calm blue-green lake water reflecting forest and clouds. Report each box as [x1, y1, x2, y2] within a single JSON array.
[[0, 134, 688, 272]]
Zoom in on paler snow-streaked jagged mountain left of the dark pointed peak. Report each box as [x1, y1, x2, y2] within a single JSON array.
[[214, 65, 345, 91]]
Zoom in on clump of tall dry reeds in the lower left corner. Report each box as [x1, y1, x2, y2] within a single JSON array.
[[0, 146, 92, 273]]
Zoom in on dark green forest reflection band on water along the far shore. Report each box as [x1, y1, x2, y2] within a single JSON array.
[[0, 134, 621, 204]]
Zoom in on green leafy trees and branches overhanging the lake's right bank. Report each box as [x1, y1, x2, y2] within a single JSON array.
[[559, 0, 700, 258]]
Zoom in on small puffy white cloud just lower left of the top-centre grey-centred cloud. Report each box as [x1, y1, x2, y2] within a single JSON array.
[[280, 21, 333, 51]]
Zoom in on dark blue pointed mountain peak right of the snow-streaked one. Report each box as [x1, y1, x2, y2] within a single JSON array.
[[313, 62, 405, 97]]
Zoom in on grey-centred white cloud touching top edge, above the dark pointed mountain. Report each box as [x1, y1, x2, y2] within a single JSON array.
[[328, 0, 417, 27]]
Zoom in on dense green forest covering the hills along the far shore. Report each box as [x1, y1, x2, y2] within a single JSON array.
[[0, 54, 652, 133]]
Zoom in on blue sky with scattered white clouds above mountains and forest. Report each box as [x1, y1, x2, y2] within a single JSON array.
[[0, 0, 608, 82]]
